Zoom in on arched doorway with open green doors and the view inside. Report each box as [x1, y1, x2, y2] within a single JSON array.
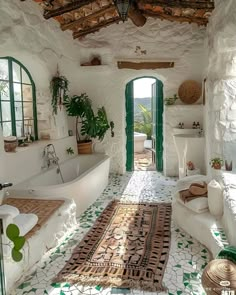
[[125, 76, 163, 172]]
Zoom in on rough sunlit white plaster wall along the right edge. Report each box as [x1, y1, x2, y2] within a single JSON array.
[[206, 0, 236, 173]]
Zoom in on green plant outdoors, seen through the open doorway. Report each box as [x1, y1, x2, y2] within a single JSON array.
[[134, 104, 152, 139]]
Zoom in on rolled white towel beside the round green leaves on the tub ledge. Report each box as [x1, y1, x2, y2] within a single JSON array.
[[13, 213, 38, 236]]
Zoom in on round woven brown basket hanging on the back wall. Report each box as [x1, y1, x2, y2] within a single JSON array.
[[178, 80, 201, 104]]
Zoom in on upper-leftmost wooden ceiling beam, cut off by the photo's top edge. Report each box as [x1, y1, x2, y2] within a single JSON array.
[[43, 0, 95, 19]]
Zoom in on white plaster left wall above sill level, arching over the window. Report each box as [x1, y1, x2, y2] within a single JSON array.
[[0, 0, 82, 138]]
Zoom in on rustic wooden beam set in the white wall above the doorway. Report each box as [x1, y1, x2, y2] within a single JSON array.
[[117, 61, 175, 70]]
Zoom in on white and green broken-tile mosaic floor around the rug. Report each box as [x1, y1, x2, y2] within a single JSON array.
[[11, 171, 216, 295]]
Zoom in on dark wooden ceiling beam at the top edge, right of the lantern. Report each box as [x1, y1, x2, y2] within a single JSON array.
[[138, 0, 215, 10]]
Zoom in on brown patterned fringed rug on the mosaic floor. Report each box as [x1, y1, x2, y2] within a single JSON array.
[[54, 201, 171, 291]]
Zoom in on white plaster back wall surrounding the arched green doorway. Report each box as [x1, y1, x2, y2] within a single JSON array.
[[76, 19, 206, 175]]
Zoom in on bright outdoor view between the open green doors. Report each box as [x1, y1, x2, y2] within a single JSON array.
[[134, 78, 156, 171]]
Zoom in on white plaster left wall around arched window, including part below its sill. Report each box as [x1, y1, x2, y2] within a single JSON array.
[[0, 0, 82, 183]]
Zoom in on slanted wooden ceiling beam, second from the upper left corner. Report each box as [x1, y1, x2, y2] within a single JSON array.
[[61, 4, 116, 31]]
